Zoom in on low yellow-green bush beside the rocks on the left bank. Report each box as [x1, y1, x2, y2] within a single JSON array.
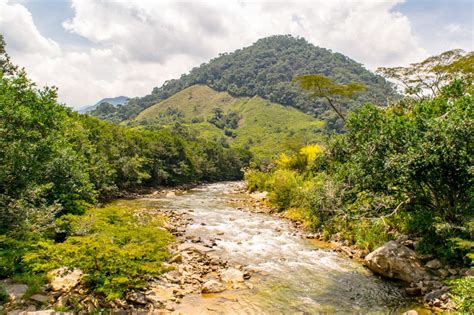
[[25, 205, 172, 300]]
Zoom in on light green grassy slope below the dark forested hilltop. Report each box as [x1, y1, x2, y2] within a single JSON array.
[[134, 85, 324, 159]]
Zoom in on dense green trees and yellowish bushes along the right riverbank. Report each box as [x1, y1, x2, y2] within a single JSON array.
[[246, 63, 474, 265]]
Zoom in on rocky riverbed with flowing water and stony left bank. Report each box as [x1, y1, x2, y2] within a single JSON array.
[[5, 183, 462, 314]]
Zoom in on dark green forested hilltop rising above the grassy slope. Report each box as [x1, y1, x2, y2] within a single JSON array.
[[91, 35, 394, 126]]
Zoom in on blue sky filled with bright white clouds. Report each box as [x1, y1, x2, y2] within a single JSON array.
[[0, 0, 474, 108]]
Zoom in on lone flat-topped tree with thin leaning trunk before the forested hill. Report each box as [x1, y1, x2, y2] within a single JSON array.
[[295, 74, 364, 121]]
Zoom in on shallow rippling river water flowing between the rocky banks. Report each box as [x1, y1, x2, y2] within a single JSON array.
[[143, 183, 415, 314]]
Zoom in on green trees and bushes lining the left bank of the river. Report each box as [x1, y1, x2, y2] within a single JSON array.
[[0, 37, 250, 299]]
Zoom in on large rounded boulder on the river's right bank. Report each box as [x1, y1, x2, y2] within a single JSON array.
[[365, 241, 427, 282]]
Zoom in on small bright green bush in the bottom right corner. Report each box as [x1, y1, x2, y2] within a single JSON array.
[[448, 276, 474, 314]]
